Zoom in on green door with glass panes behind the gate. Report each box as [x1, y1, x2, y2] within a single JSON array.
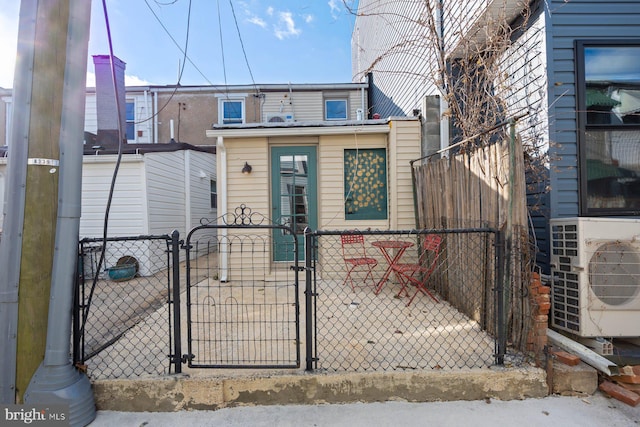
[[271, 146, 318, 261]]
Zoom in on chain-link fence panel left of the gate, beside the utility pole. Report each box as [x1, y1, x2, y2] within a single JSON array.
[[73, 232, 180, 379]]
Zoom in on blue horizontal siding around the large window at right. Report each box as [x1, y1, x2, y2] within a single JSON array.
[[546, 0, 640, 218]]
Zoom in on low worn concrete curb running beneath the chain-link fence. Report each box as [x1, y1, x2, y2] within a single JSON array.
[[93, 367, 548, 412]]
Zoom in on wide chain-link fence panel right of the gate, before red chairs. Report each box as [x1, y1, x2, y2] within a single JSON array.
[[306, 229, 501, 371]]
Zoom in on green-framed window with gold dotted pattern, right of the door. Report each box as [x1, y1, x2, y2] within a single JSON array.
[[344, 148, 387, 220]]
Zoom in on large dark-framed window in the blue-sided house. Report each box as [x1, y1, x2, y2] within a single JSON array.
[[577, 40, 640, 215]]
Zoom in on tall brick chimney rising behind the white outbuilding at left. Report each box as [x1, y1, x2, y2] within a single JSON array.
[[93, 55, 127, 147]]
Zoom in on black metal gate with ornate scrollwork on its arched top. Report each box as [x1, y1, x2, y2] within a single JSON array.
[[184, 205, 300, 368]]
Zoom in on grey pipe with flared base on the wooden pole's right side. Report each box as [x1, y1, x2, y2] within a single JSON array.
[[24, 1, 96, 425]]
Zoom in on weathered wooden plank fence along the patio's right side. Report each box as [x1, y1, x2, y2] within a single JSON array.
[[413, 135, 532, 349]]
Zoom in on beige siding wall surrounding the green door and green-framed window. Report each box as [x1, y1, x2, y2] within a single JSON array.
[[218, 120, 420, 229]]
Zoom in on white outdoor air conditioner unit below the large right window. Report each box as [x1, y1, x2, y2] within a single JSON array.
[[550, 218, 640, 337]]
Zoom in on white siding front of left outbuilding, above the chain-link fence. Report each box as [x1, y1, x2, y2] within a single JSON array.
[[80, 155, 148, 238]]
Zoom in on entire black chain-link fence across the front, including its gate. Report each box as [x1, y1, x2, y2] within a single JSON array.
[[73, 224, 526, 379]]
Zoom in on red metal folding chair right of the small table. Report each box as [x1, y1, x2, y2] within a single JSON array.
[[391, 234, 442, 307]]
